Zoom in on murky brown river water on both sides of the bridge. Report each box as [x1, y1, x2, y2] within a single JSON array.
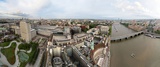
[[111, 23, 160, 67]]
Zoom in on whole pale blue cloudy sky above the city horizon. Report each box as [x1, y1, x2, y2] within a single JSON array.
[[0, 0, 160, 19]]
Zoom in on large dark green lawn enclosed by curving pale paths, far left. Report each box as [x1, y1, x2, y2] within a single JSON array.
[[1, 43, 16, 64]]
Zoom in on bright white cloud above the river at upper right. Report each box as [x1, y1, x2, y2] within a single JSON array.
[[115, 0, 155, 19]]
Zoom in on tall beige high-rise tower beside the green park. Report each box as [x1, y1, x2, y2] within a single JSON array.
[[20, 21, 31, 42]]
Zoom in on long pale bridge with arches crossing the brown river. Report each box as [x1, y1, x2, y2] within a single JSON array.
[[111, 31, 144, 42]]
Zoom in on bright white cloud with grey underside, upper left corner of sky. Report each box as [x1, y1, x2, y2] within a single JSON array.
[[0, 0, 47, 17]]
